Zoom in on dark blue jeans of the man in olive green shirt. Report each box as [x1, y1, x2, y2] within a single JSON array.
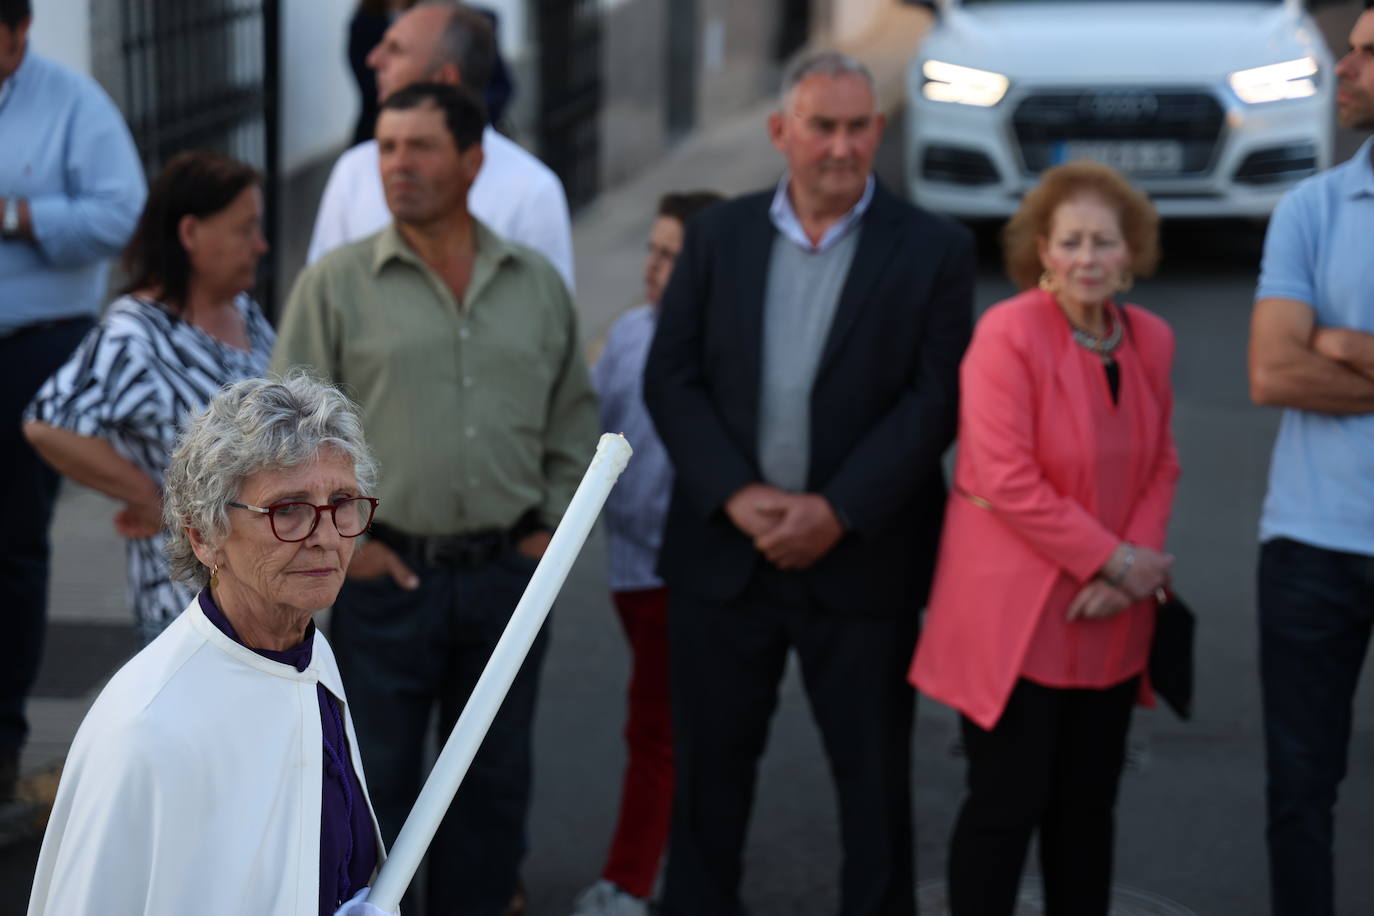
[[330, 551, 548, 916]]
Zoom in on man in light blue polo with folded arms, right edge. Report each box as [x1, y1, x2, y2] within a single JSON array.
[[1250, 7, 1374, 916]]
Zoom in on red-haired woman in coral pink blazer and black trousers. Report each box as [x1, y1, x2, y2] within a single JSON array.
[[911, 162, 1179, 916]]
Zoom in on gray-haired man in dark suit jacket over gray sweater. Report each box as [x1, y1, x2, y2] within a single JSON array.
[[644, 52, 974, 916]]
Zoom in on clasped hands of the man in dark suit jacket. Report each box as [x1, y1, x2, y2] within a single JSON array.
[[724, 483, 845, 570]]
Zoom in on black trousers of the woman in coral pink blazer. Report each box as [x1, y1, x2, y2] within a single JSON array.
[[949, 678, 1139, 916]]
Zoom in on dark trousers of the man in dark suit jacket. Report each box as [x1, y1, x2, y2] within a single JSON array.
[[662, 567, 916, 916]]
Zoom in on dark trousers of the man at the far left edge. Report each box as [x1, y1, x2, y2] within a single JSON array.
[[0, 319, 93, 750]]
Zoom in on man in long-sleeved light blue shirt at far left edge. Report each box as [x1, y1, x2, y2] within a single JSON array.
[[0, 0, 147, 805]]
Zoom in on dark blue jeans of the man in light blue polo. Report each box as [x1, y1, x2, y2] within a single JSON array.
[[1259, 538, 1374, 916]]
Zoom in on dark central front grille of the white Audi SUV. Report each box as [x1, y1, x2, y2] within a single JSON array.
[[1011, 88, 1224, 174]]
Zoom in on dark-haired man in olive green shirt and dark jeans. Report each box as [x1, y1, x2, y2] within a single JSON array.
[[272, 84, 598, 916]]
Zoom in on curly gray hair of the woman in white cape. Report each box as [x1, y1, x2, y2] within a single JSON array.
[[162, 372, 376, 586]]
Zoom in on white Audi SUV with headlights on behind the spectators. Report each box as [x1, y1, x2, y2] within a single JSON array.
[[905, 0, 1334, 218]]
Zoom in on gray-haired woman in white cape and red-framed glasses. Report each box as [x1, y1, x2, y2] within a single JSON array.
[[29, 375, 401, 916]]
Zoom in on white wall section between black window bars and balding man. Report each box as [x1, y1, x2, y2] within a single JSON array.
[[280, 0, 357, 174]]
